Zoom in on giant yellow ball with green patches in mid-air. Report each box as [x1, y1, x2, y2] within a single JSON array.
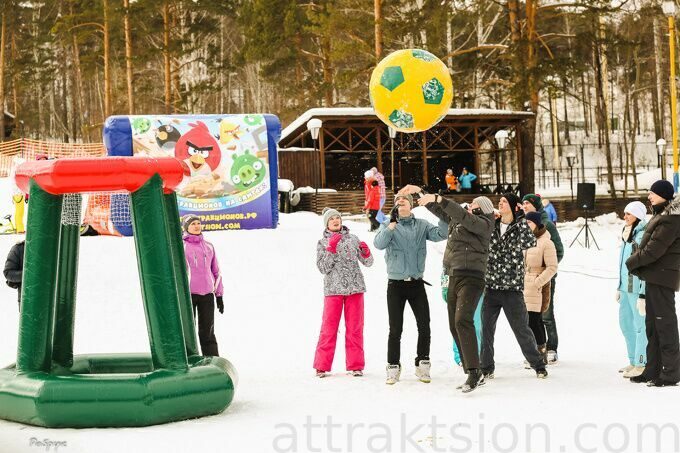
[[369, 49, 453, 132]]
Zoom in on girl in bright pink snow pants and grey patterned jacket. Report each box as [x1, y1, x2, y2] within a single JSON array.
[[314, 208, 373, 377]]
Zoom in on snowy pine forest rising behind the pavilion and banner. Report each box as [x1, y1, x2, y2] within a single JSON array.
[[0, 0, 670, 178]]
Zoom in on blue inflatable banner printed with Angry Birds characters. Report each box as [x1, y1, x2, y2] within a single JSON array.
[[104, 114, 281, 231]]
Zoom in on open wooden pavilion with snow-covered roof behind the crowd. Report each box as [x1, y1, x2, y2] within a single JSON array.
[[279, 108, 534, 193]]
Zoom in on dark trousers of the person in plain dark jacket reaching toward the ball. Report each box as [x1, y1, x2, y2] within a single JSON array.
[[446, 276, 484, 370]]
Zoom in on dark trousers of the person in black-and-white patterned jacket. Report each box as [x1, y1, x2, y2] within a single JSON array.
[[481, 288, 543, 371]]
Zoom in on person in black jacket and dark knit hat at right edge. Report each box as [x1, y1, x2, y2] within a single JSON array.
[[626, 180, 680, 387]]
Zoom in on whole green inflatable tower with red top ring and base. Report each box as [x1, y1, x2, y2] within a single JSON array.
[[0, 157, 238, 428]]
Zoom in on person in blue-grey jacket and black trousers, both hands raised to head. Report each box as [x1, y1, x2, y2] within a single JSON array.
[[373, 194, 447, 384]]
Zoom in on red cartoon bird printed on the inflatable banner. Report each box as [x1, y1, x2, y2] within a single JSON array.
[[175, 121, 222, 176]]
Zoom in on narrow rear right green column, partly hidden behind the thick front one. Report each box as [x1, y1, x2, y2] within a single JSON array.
[[163, 192, 198, 356]]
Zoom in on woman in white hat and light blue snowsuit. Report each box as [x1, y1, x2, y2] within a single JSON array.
[[616, 201, 647, 378]]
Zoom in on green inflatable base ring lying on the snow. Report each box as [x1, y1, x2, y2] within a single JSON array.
[[0, 354, 237, 428]]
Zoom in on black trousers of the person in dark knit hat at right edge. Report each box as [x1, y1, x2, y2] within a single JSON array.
[[643, 283, 680, 382]]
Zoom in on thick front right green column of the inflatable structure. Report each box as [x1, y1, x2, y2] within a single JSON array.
[[130, 174, 188, 370]]
